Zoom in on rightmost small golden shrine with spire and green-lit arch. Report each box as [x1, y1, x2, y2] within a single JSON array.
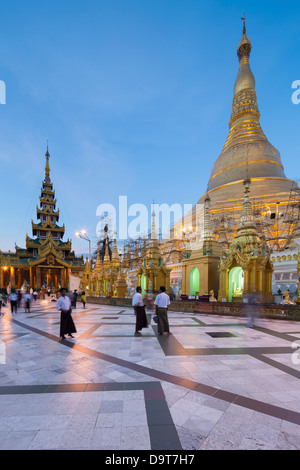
[[218, 177, 273, 302]]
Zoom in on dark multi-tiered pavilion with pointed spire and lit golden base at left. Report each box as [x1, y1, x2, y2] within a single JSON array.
[[0, 147, 84, 290]]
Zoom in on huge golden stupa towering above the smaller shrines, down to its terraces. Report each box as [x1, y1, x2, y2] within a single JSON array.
[[198, 18, 296, 237]]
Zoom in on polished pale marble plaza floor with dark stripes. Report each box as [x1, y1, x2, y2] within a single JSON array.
[[0, 300, 300, 451]]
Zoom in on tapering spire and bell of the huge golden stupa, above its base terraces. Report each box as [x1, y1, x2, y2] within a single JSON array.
[[208, 16, 286, 195]]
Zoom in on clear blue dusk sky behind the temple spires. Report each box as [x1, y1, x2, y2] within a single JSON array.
[[0, 0, 300, 254]]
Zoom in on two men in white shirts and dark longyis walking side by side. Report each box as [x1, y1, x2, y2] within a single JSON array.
[[132, 286, 172, 336]]
